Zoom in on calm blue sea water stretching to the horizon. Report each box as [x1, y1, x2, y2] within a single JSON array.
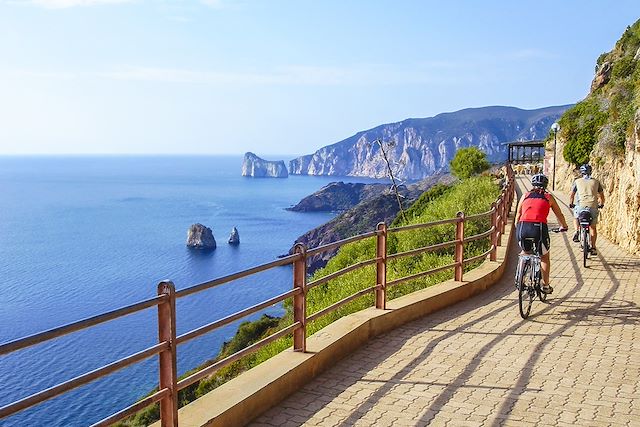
[[0, 156, 380, 426]]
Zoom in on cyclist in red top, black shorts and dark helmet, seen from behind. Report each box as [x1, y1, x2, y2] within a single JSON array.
[[516, 174, 568, 294]]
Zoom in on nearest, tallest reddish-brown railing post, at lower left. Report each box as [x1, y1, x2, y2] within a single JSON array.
[[158, 280, 178, 427]]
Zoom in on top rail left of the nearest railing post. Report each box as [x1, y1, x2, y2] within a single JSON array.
[[0, 296, 166, 355]]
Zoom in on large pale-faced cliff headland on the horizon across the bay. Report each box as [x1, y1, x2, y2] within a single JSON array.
[[289, 105, 569, 180]]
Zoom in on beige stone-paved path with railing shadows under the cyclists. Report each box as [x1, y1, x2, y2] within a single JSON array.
[[252, 176, 640, 426]]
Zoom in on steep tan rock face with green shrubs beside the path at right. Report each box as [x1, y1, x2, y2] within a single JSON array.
[[550, 21, 640, 254]]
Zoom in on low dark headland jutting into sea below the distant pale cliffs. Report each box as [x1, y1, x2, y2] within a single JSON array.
[[287, 181, 390, 212]]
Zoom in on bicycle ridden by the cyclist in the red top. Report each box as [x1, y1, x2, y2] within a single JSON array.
[[516, 228, 567, 319]]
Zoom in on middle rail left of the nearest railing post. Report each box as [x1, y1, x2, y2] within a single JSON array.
[[0, 342, 169, 418]]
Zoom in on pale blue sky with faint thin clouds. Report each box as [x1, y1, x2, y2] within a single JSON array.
[[0, 0, 640, 157]]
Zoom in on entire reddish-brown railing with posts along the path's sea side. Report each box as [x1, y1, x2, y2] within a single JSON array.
[[0, 165, 515, 426]]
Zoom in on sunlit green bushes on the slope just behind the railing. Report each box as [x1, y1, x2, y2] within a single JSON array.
[[121, 157, 500, 426]]
